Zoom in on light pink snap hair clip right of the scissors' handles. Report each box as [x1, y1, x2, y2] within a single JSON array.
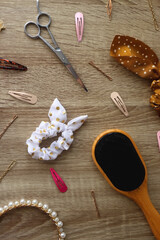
[[75, 12, 84, 42]]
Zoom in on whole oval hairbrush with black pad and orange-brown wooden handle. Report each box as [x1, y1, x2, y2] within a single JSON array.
[[92, 129, 160, 240]]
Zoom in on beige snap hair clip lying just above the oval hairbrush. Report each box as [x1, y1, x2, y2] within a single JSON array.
[[111, 92, 129, 117]]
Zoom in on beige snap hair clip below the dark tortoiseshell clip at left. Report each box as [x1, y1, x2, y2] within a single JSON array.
[[8, 91, 37, 104]]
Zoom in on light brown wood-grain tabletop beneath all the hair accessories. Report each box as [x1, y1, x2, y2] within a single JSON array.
[[0, 0, 160, 240]]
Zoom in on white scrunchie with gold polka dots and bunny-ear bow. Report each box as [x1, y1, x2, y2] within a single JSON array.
[[26, 98, 88, 160]]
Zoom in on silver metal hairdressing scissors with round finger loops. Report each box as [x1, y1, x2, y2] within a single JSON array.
[[24, 0, 88, 92]]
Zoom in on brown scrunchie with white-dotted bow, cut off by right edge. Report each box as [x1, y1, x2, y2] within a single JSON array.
[[110, 35, 160, 115]]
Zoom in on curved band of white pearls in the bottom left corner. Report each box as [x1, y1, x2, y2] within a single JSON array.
[[0, 199, 66, 240]]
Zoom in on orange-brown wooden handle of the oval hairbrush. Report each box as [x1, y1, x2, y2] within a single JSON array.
[[134, 186, 160, 240]]
